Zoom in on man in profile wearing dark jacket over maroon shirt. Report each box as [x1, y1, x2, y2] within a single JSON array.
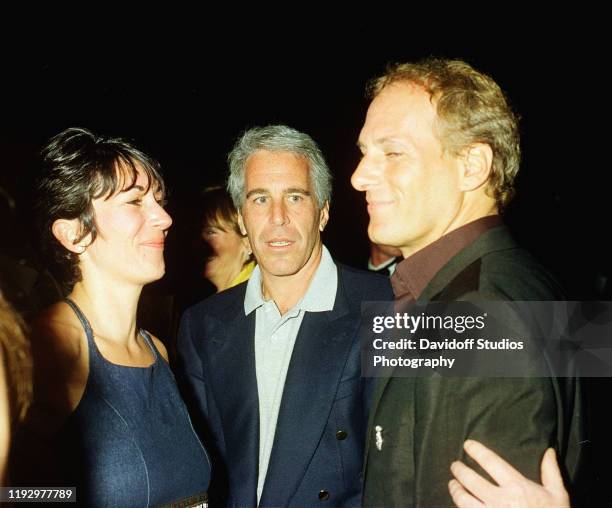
[[352, 59, 580, 506]]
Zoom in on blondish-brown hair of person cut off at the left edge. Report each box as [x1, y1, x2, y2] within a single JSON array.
[[0, 292, 32, 485]]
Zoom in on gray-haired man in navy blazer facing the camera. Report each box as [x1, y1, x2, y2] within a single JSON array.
[[178, 125, 392, 507]]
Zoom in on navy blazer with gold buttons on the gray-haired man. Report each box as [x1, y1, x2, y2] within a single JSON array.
[[178, 266, 393, 507]]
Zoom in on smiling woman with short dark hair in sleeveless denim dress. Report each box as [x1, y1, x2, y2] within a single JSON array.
[[21, 128, 210, 507]]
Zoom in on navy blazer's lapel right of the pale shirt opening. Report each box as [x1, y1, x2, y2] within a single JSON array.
[[261, 281, 358, 506]]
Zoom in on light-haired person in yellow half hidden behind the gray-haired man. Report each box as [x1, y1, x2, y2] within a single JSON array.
[[202, 187, 255, 293]]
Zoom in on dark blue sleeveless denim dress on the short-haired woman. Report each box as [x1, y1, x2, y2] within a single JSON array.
[[61, 300, 210, 508]]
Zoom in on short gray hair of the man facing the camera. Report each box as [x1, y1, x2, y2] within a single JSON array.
[[227, 125, 332, 210]]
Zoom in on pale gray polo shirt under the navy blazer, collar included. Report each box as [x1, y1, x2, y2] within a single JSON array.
[[244, 246, 338, 503]]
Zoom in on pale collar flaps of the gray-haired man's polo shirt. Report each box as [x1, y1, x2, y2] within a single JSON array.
[[244, 245, 338, 315]]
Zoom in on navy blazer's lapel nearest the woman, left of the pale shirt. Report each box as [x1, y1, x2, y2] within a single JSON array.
[[208, 299, 259, 506]]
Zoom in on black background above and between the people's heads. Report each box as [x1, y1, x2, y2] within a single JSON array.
[[0, 22, 612, 503]]
